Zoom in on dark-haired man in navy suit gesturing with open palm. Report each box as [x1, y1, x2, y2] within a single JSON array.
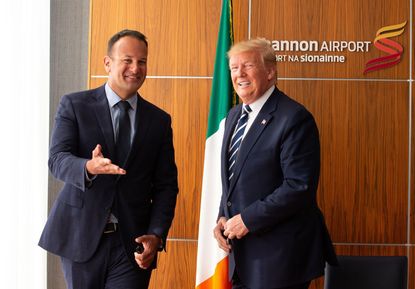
[[39, 30, 178, 289]]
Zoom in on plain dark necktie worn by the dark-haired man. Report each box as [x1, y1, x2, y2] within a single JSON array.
[[115, 101, 131, 167]]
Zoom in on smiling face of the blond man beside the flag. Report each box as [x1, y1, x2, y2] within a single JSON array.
[[229, 50, 276, 104]]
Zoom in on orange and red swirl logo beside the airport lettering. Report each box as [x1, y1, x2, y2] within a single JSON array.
[[363, 21, 407, 74]]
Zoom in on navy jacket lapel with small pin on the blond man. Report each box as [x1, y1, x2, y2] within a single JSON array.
[[229, 89, 278, 195]]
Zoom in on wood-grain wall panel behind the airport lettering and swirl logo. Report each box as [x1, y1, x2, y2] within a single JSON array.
[[252, 0, 410, 79]]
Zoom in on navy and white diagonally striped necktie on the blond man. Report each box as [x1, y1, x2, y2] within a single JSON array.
[[228, 105, 252, 181]]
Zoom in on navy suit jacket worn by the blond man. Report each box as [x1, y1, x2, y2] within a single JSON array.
[[219, 88, 336, 289]]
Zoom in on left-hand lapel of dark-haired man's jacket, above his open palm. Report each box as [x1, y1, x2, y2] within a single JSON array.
[[94, 86, 115, 159]]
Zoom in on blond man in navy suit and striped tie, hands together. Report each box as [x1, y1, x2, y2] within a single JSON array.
[[214, 39, 336, 289]]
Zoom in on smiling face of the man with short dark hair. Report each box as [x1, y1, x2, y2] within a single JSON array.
[[104, 36, 147, 100]]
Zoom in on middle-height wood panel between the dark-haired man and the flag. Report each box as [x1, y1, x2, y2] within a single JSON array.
[[91, 79, 211, 239]]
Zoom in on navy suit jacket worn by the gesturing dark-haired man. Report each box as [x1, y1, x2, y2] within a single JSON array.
[[39, 86, 178, 268]]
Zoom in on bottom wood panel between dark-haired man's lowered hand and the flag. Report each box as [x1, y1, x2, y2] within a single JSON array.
[[149, 241, 197, 289]]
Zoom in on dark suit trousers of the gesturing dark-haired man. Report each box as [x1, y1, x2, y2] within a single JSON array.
[[62, 232, 151, 289]]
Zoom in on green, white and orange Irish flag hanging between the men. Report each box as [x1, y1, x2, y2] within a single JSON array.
[[196, 0, 236, 289]]
